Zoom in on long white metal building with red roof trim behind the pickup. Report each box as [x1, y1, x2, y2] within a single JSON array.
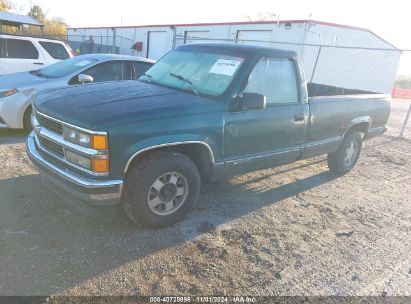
[[68, 20, 401, 93]]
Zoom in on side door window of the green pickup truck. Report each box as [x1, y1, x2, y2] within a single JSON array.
[[244, 57, 298, 104]]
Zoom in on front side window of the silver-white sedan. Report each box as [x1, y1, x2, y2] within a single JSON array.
[[82, 61, 129, 82]]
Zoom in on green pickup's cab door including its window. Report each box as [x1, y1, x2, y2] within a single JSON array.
[[224, 57, 309, 170]]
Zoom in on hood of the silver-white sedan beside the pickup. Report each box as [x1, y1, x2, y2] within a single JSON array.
[[0, 72, 50, 90]]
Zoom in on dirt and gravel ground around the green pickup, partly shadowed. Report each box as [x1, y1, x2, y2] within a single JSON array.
[[0, 101, 411, 296]]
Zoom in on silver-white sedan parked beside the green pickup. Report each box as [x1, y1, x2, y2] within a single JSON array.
[[0, 54, 155, 130]]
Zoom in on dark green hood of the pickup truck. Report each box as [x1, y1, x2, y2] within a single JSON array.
[[33, 80, 221, 130]]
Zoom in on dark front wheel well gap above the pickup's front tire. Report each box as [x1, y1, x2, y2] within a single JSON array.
[[127, 143, 213, 179]]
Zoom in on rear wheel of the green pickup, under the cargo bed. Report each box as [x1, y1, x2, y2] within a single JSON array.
[[327, 132, 362, 175]]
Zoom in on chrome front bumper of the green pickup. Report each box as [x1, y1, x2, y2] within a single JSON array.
[[26, 132, 123, 214]]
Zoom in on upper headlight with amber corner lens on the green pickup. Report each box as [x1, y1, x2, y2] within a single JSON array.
[[63, 127, 108, 150]]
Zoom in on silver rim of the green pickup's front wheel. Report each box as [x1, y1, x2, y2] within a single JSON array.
[[147, 172, 188, 216]]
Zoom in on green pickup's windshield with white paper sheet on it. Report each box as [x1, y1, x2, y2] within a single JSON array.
[[139, 50, 244, 96]]
